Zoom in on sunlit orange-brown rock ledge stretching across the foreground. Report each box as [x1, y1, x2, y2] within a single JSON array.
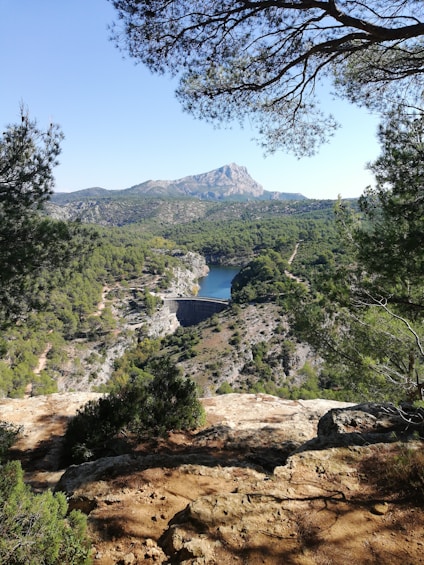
[[4, 394, 424, 565]]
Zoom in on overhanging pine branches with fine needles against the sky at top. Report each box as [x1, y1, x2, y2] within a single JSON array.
[[110, 0, 424, 155]]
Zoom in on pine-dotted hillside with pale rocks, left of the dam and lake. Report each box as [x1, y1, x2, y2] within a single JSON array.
[[0, 228, 189, 397]]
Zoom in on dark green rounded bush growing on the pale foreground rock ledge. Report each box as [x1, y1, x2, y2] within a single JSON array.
[[64, 358, 204, 463]]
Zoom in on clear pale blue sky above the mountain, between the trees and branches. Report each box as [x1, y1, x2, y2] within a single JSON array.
[[0, 0, 379, 199]]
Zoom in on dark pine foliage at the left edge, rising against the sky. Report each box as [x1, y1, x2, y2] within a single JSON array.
[[0, 110, 92, 325]]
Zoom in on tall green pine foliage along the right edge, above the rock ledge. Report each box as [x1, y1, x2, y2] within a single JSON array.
[[290, 111, 424, 400]]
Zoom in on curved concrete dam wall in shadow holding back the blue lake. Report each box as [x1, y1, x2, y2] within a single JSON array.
[[163, 298, 229, 327]]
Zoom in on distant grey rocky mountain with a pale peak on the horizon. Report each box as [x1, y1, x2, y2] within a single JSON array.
[[51, 163, 306, 205]]
